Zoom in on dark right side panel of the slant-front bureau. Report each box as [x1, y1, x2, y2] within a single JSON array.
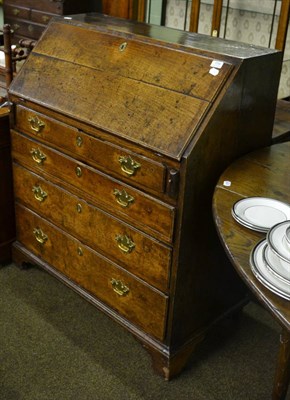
[[169, 50, 280, 347]]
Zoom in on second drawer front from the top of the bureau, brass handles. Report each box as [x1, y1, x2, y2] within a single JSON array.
[[11, 131, 174, 241]]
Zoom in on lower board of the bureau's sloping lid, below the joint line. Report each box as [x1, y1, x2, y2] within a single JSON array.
[[13, 54, 208, 159]]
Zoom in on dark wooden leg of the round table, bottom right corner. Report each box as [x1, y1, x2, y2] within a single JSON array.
[[272, 329, 290, 400]]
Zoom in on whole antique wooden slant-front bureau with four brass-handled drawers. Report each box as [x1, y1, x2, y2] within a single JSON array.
[[9, 14, 282, 379]]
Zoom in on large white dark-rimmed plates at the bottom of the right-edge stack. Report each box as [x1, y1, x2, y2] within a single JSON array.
[[250, 240, 290, 300]]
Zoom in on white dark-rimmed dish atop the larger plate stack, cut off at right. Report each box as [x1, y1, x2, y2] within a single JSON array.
[[267, 221, 290, 262]]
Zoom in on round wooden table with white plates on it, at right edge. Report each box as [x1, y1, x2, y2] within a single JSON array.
[[213, 142, 290, 400]]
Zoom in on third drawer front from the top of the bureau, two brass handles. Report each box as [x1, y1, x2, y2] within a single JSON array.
[[13, 164, 171, 292]]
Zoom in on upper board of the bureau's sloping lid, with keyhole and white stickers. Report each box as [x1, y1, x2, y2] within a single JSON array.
[[36, 22, 231, 101]]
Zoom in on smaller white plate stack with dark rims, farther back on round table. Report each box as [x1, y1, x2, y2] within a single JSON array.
[[232, 197, 290, 232]]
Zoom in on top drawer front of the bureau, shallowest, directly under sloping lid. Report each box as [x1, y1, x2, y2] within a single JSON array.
[[16, 106, 166, 192]]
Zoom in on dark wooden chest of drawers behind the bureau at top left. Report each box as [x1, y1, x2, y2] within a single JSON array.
[[3, 0, 101, 43]]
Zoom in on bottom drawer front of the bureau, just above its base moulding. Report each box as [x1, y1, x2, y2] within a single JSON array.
[[16, 205, 168, 340]]
